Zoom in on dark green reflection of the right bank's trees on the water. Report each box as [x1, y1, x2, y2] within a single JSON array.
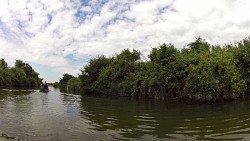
[[81, 97, 250, 140]]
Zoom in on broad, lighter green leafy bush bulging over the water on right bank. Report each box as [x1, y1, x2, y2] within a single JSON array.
[[185, 52, 246, 101]]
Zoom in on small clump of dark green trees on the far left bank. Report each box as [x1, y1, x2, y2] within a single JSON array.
[[0, 59, 41, 88]]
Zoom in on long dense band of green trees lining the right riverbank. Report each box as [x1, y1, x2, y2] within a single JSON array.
[[59, 37, 250, 101]]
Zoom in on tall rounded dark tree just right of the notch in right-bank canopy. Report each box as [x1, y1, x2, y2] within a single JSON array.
[[143, 44, 185, 99]]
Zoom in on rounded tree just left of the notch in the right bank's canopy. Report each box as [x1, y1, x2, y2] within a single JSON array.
[[93, 49, 140, 96]]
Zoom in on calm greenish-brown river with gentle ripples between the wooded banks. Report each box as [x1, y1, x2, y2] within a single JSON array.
[[0, 87, 250, 141]]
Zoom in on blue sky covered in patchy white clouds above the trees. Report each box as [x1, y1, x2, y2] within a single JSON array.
[[0, 0, 250, 82]]
